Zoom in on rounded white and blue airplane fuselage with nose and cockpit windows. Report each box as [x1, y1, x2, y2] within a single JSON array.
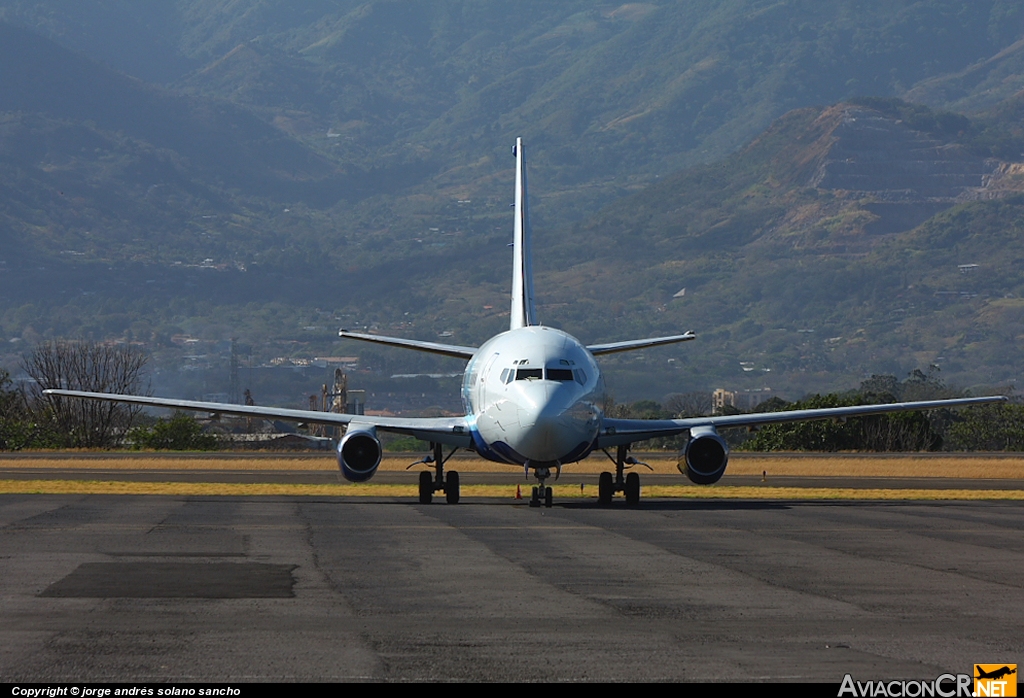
[[462, 325, 604, 467]]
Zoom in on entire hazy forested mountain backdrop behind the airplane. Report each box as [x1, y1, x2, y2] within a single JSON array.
[[0, 0, 1024, 394]]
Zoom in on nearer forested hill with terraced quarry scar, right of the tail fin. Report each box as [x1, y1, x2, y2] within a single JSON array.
[[538, 94, 1024, 390]]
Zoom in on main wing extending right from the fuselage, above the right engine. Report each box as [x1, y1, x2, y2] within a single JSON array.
[[597, 395, 1007, 448]]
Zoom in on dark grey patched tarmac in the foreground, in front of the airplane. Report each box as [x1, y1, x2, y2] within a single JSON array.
[[0, 494, 1024, 683]]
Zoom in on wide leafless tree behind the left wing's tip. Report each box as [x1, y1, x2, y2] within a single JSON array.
[[23, 340, 146, 448]]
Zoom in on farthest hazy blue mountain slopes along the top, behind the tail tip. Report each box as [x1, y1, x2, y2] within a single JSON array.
[[0, 0, 1024, 219]]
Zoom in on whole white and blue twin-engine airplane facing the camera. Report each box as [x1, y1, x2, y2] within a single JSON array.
[[44, 138, 1007, 507]]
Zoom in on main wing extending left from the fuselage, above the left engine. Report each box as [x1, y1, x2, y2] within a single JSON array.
[[43, 389, 472, 448]]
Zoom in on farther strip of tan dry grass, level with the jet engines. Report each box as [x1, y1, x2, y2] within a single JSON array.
[[0, 453, 1024, 479]]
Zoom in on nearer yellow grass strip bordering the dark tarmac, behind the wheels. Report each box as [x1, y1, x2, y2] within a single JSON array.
[[0, 480, 1024, 500]]
